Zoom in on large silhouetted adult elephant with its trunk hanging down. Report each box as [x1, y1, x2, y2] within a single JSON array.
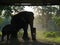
[[11, 11, 34, 40]]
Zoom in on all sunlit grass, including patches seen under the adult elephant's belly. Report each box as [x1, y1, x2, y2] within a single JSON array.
[[0, 31, 60, 43]]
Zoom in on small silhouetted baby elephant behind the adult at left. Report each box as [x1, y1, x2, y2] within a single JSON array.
[[1, 24, 15, 41]]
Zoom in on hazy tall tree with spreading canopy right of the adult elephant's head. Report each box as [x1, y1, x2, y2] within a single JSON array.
[[34, 5, 58, 30]]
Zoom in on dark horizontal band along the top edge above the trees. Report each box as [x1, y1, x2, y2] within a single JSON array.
[[0, 0, 60, 5]]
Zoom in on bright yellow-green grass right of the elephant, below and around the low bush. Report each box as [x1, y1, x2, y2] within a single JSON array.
[[28, 31, 60, 43]]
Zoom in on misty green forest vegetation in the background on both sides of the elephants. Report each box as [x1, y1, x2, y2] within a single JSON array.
[[0, 5, 60, 42]]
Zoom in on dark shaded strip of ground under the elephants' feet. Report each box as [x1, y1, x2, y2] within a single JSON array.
[[0, 39, 52, 45]]
